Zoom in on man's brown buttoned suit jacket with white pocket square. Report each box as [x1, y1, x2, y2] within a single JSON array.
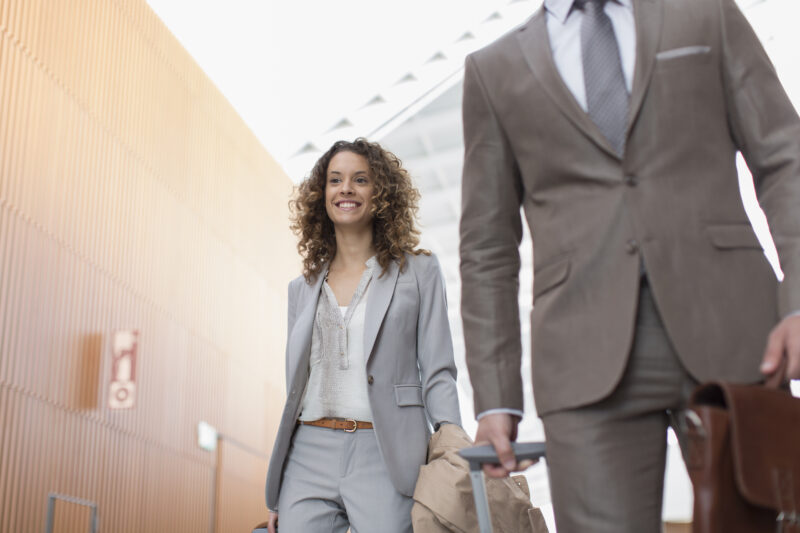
[[461, 0, 800, 414]]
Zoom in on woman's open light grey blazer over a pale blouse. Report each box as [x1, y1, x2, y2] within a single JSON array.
[[266, 254, 461, 510]]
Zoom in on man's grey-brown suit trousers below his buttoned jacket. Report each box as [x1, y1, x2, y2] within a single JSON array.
[[542, 282, 697, 533]]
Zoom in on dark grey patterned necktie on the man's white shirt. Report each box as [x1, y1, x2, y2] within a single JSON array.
[[575, 0, 628, 156]]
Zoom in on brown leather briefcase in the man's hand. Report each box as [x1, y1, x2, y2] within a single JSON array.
[[686, 383, 800, 533]]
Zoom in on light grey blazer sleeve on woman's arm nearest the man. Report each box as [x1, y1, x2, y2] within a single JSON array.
[[416, 256, 461, 429]]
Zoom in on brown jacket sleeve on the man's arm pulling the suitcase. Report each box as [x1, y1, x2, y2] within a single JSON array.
[[460, 57, 523, 413]]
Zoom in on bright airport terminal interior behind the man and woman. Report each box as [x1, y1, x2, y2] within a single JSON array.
[[0, 0, 800, 533]]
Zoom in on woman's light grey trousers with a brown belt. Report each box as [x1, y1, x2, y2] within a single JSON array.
[[278, 426, 414, 533]]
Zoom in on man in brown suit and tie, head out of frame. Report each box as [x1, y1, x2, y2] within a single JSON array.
[[461, 0, 800, 533]]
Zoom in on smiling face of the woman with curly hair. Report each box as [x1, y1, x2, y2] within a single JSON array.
[[325, 151, 375, 228]]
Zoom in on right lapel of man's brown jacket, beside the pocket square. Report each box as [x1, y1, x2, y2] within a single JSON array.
[[628, 0, 663, 133]]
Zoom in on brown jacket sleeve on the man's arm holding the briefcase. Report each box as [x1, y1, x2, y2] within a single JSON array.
[[720, 0, 800, 317]]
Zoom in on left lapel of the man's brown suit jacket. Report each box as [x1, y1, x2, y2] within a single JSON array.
[[517, 7, 619, 159]]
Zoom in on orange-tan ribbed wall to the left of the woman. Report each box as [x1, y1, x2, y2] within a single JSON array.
[[0, 0, 299, 533]]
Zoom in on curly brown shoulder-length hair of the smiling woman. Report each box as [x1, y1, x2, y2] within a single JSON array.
[[289, 137, 430, 282]]
